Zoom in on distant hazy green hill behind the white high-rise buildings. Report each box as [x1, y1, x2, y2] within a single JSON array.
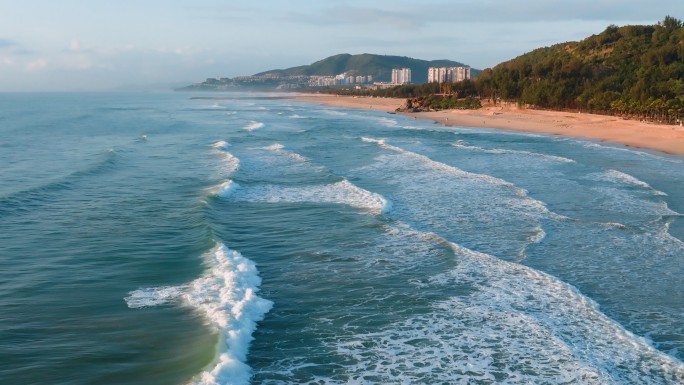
[[254, 53, 475, 83]]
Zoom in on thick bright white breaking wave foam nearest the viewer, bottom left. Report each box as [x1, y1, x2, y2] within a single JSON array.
[[125, 243, 273, 385]]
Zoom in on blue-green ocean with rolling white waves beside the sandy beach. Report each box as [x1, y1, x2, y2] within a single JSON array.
[[0, 92, 684, 385]]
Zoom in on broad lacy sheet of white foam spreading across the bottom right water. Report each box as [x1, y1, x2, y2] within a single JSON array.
[[330, 230, 684, 385]]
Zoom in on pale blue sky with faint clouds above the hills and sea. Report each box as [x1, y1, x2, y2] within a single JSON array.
[[0, 0, 684, 92]]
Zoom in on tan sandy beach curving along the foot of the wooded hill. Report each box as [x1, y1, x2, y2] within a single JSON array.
[[294, 94, 684, 155]]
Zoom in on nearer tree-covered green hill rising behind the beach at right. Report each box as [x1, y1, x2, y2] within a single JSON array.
[[475, 16, 684, 123]]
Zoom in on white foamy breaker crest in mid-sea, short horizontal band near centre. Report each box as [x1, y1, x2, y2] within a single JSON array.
[[235, 179, 391, 215]]
